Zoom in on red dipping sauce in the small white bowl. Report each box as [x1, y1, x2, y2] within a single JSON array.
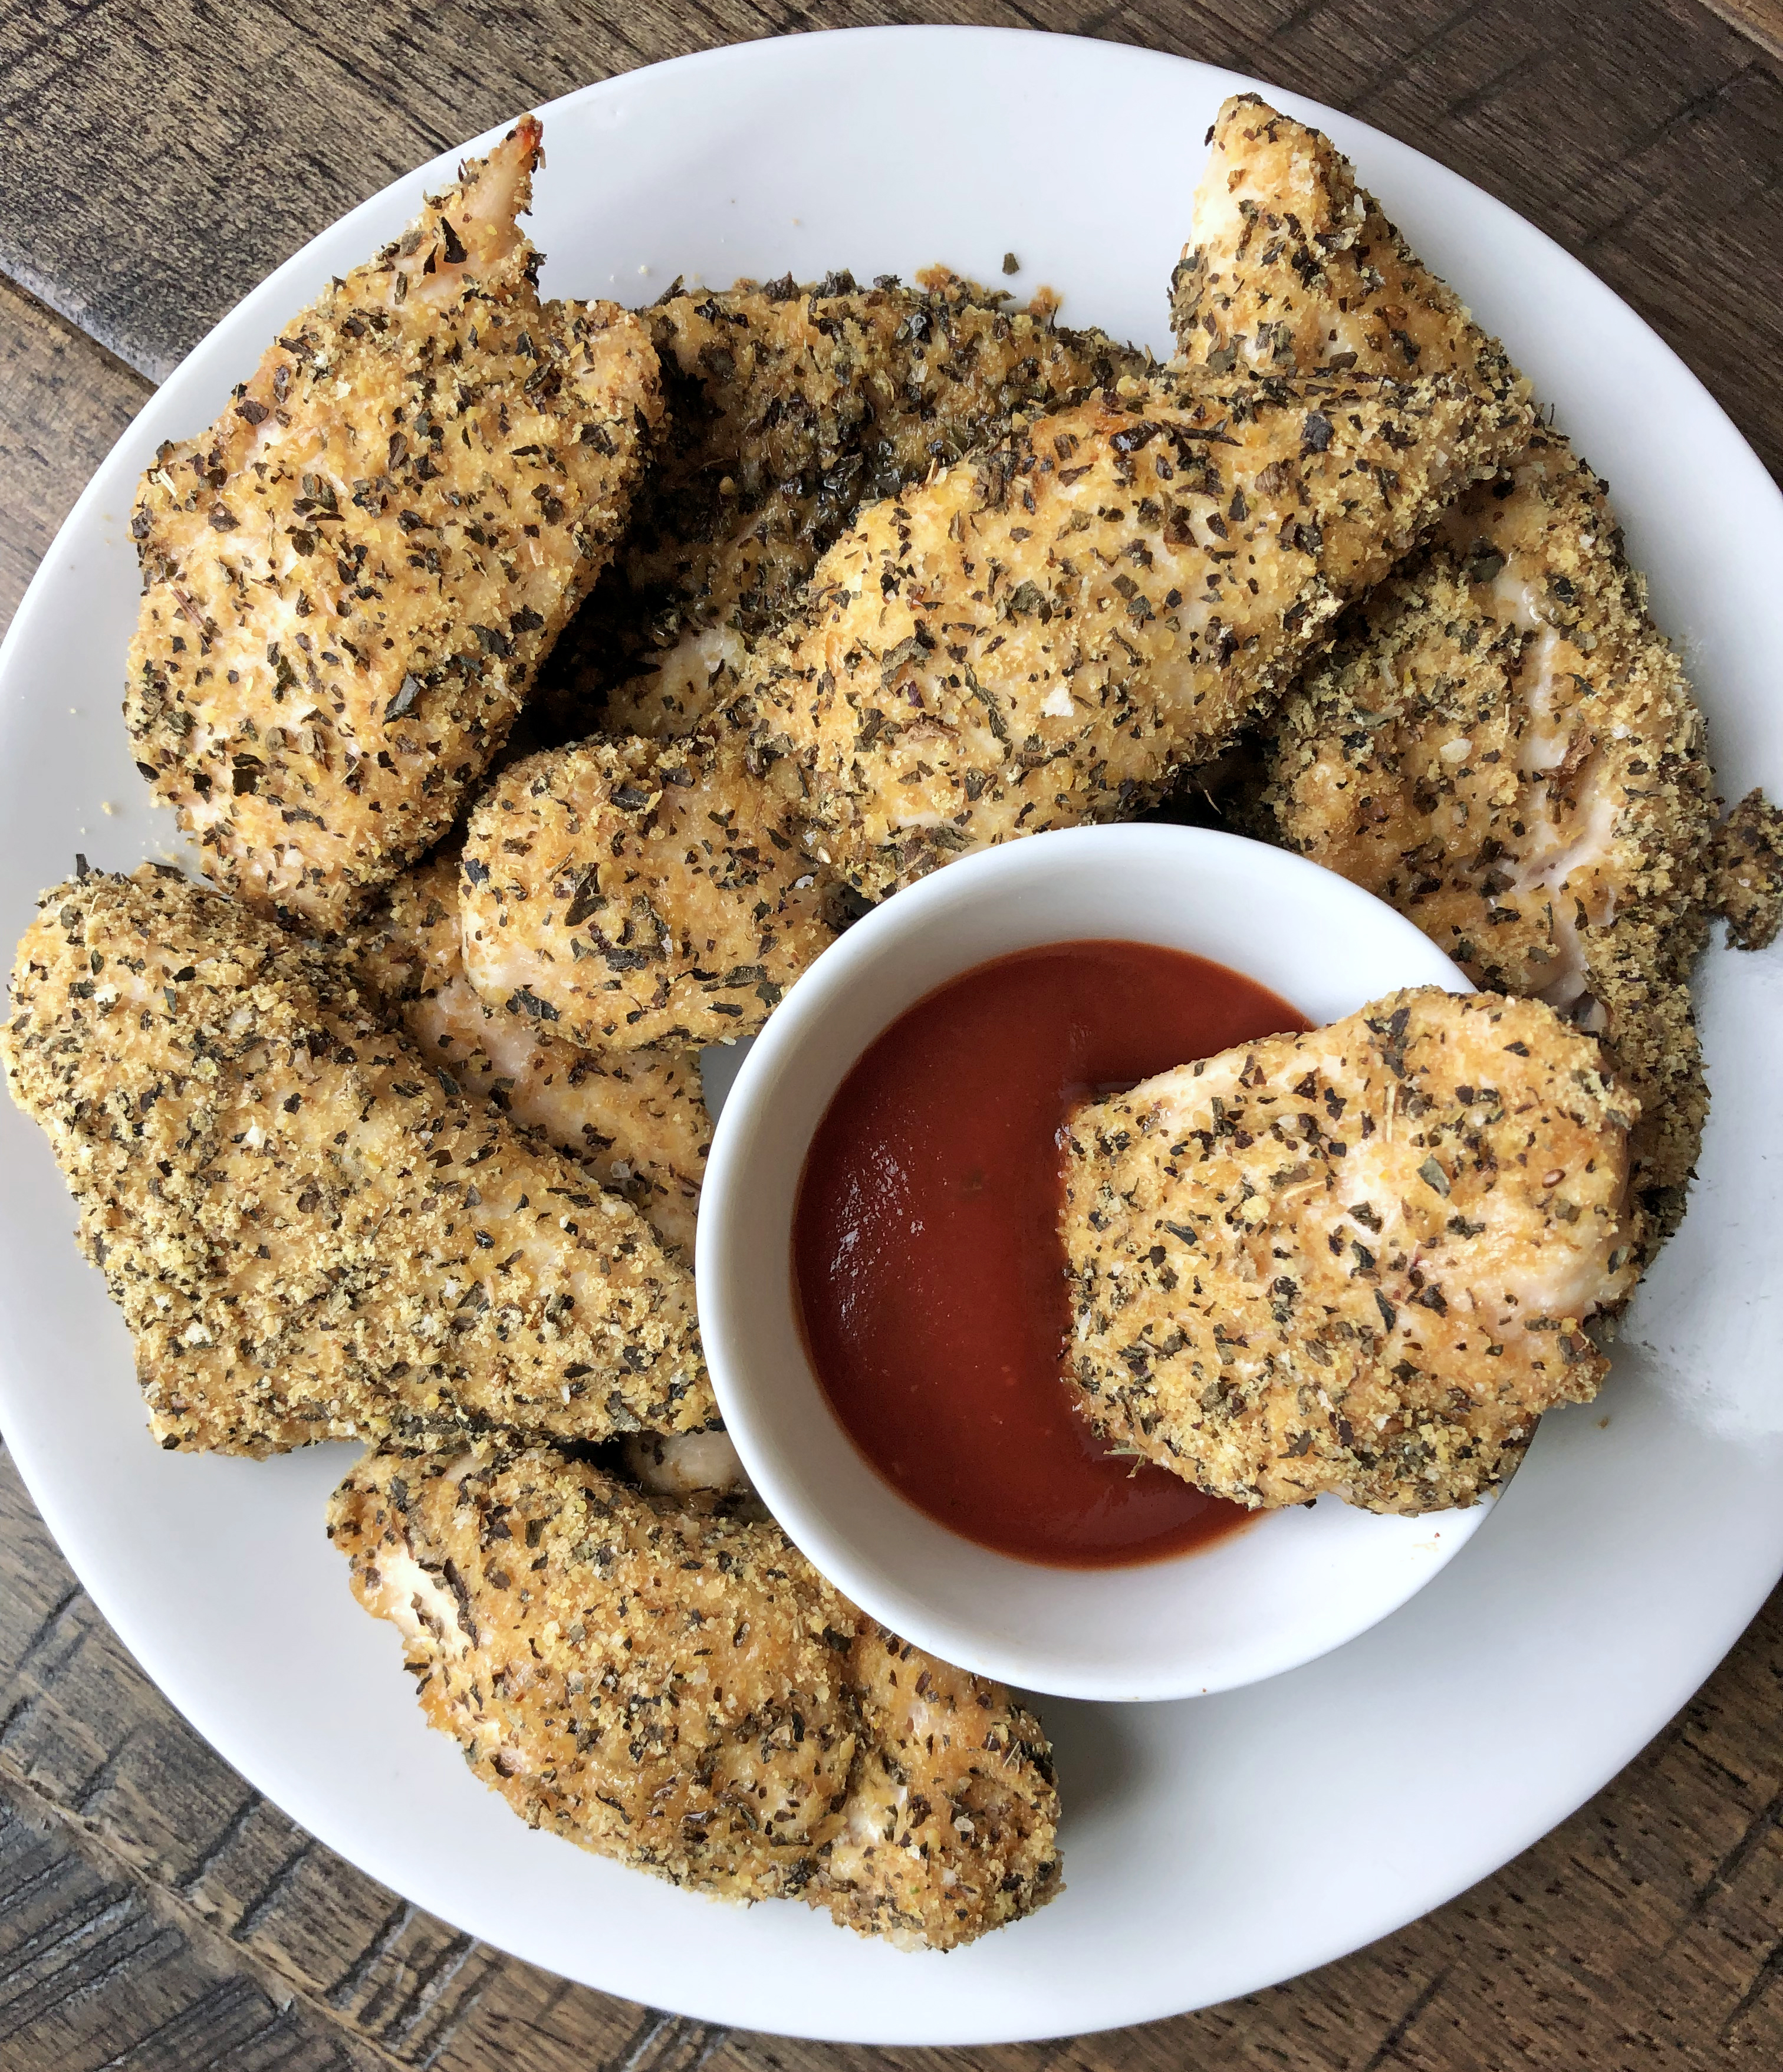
[[793, 943, 1309, 1568]]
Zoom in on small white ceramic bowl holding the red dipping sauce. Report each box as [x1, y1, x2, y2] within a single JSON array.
[[696, 827, 1485, 1699]]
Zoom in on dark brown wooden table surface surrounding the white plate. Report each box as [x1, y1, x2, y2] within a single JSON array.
[[0, 0, 1783, 2072]]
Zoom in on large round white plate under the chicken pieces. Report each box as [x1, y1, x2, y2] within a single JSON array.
[[0, 29, 1783, 2043]]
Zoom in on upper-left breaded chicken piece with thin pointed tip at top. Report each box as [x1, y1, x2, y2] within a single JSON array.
[[124, 118, 660, 928]]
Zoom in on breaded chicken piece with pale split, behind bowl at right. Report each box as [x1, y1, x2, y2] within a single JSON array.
[[1263, 453, 1713, 1243]]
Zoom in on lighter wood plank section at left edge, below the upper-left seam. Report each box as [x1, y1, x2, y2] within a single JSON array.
[[0, 279, 149, 632]]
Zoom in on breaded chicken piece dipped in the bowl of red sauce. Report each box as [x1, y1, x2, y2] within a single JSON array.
[[1060, 988, 1640, 1512]]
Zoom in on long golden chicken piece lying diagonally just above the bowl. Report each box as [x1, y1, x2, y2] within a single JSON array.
[[749, 362, 1528, 897]]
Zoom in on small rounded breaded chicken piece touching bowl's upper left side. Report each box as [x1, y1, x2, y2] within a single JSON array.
[[460, 731, 837, 1051]]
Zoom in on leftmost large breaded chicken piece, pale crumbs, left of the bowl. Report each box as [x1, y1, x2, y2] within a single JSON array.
[[0, 864, 716, 1455]]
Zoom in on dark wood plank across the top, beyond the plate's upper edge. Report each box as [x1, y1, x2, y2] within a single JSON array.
[[0, 0, 1783, 489]]
